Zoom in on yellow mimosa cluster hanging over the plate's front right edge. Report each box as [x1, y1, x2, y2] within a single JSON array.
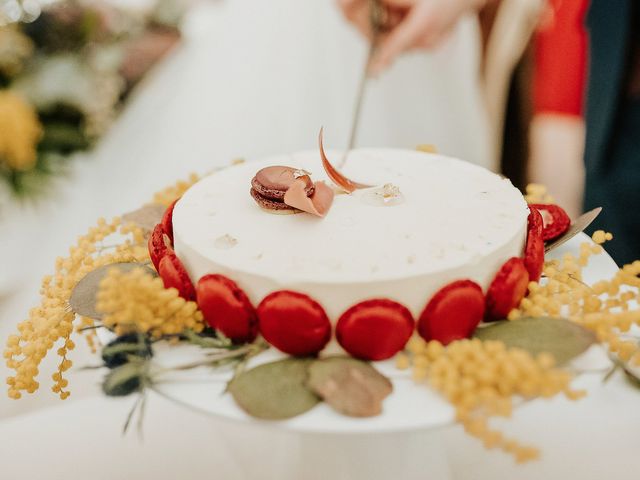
[[396, 337, 584, 463]]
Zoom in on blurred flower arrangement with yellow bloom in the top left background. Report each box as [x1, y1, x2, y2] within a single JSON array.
[[0, 0, 182, 202]]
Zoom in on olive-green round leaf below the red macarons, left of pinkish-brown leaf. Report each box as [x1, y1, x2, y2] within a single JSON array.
[[228, 358, 320, 420]]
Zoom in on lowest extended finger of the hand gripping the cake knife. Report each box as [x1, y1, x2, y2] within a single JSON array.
[[370, 10, 430, 75]]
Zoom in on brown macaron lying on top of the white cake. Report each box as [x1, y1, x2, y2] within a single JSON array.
[[251, 165, 315, 213]]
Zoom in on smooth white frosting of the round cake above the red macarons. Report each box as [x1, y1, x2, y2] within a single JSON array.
[[173, 149, 528, 321]]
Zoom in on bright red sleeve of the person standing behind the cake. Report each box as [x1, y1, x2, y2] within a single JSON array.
[[533, 0, 588, 115]]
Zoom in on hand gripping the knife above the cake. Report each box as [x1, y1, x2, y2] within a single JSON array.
[[338, 0, 487, 74]]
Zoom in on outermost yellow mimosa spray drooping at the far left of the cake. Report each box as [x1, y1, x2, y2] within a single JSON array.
[[4, 218, 148, 399]]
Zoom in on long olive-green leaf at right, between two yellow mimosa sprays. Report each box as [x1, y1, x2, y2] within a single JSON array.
[[475, 317, 596, 365]]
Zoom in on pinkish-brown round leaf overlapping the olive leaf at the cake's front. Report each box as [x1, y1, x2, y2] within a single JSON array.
[[308, 357, 393, 417]]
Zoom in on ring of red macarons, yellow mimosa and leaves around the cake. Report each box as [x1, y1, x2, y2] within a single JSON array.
[[4, 158, 640, 462]]
